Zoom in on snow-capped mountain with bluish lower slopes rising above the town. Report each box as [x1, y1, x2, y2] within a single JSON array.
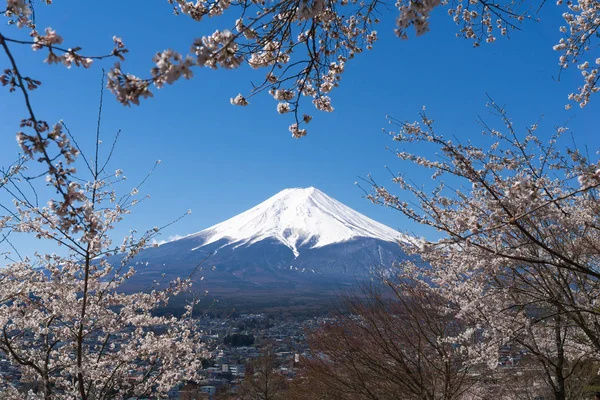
[[117, 187, 408, 294]]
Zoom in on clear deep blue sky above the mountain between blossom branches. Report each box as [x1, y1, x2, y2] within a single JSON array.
[[0, 0, 600, 250]]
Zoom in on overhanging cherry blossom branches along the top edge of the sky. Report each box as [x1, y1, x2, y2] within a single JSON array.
[[0, 0, 600, 138]]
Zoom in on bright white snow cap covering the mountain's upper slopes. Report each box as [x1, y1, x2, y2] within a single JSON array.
[[184, 187, 406, 257]]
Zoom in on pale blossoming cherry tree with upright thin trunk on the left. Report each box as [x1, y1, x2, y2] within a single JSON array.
[[0, 75, 205, 400]]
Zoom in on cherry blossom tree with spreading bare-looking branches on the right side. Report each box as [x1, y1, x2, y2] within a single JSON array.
[[369, 101, 600, 399]]
